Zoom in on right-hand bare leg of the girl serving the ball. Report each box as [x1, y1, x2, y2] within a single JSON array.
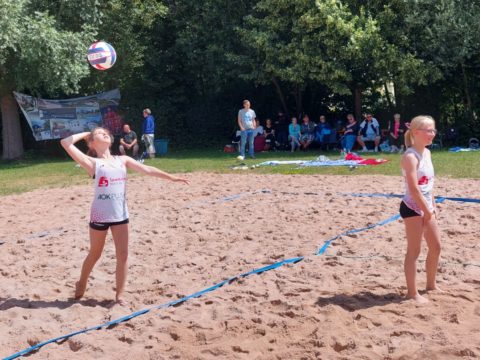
[[111, 224, 128, 305]]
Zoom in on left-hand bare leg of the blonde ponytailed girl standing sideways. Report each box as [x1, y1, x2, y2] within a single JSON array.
[[404, 216, 428, 303]]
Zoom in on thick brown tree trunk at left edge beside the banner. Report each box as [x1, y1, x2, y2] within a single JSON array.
[[0, 91, 23, 160]]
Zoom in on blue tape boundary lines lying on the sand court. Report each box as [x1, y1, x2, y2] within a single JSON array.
[[3, 190, 480, 360]]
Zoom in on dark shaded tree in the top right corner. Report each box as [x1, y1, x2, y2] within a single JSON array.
[[406, 0, 480, 128]]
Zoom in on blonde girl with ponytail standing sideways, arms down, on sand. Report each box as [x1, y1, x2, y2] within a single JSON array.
[[400, 115, 440, 303]]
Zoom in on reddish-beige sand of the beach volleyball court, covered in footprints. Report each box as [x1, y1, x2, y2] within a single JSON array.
[[0, 170, 480, 360]]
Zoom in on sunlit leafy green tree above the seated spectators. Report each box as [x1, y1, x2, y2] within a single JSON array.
[[234, 0, 434, 121]]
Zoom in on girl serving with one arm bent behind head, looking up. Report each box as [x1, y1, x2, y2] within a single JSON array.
[[61, 128, 188, 305]]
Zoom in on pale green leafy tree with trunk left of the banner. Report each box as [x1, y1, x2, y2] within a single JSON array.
[[0, 0, 96, 159]]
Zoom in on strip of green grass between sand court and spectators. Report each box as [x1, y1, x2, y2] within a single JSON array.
[[0, 150, 480, 196]]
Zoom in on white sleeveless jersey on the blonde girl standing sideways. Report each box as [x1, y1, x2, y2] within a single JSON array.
[[402, 147, 435, 215]]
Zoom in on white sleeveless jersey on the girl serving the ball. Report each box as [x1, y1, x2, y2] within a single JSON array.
[[90, 156, 128, 223]]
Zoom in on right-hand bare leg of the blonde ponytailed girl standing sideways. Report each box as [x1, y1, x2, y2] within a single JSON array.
[[424, 216, 441, 290]]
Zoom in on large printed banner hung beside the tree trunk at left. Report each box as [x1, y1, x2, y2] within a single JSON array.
[[13, 89, 122, 141]]
